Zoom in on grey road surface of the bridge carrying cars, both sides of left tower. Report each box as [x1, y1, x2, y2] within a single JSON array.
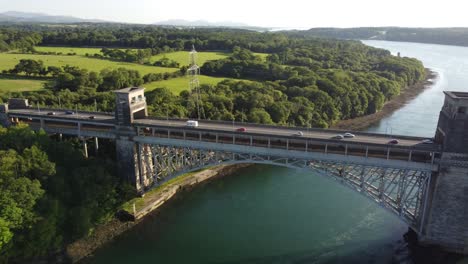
[[8, 109, 440, 152]]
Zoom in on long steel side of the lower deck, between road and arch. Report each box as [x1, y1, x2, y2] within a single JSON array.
[[137, 125, 440, 163]]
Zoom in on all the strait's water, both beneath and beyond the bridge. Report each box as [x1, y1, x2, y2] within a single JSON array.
[[90, 41, 468, 264]]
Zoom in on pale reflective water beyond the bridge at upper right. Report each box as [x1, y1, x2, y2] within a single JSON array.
[[363, 40, 468, 137]]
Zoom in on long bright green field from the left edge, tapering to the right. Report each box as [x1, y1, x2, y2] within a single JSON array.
[[0, 53, 177, 75]]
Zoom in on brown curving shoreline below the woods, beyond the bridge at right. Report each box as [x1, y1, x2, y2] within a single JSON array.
[[330, 68, 438, 131]]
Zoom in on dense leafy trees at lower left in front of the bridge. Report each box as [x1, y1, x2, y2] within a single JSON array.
[[0, 125, 133, 263]]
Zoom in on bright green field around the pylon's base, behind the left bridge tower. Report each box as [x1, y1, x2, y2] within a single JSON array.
[[143, 75, 229, 94]]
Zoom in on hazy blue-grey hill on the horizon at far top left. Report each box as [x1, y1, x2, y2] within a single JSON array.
[[0, 11, 106, 23]]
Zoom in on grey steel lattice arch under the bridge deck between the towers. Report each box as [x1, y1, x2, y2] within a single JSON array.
[[136, 143, 431, 232]]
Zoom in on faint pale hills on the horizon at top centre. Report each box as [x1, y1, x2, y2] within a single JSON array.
[[153, 19, 270, 31]]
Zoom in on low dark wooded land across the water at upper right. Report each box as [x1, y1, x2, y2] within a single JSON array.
[[287, 27, 468, 46]]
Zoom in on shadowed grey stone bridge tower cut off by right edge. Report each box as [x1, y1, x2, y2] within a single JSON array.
[[420, 92, 468, 254]]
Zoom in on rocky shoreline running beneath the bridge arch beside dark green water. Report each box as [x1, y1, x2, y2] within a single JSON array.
[[65, 163, 251, 263]]
